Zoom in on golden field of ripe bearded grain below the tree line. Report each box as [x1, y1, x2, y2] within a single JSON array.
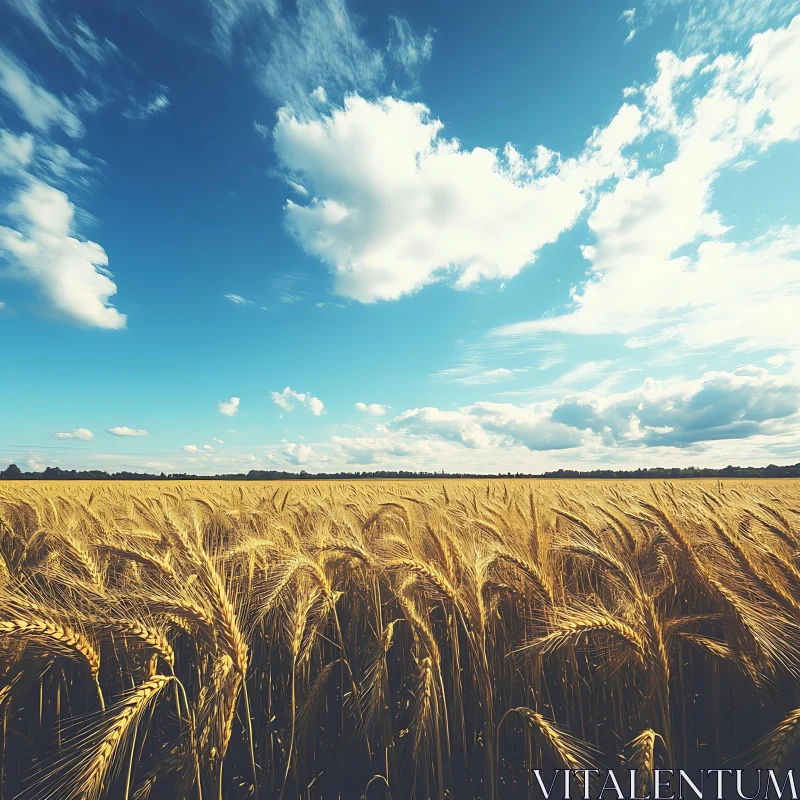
[[0, 480, 800, 800]]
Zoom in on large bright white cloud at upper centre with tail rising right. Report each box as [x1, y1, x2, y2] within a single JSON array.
[[274, 95, 641, 302]]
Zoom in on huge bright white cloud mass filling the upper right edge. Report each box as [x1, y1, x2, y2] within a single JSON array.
[[499, 16, 800, 349]]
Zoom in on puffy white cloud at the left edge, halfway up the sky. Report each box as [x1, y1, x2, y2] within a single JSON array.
[[0, 179, 126, 329]]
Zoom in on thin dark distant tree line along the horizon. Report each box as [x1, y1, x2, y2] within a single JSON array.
[[0, 463, 800, 481]]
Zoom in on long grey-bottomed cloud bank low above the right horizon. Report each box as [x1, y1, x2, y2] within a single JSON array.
[[382, 366, 800, 455]]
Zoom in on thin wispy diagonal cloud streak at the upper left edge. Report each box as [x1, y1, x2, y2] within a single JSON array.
[[0, 49, 83, 138]]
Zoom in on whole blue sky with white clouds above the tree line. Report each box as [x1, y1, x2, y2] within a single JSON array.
[[0, 0, 800, 474]]
